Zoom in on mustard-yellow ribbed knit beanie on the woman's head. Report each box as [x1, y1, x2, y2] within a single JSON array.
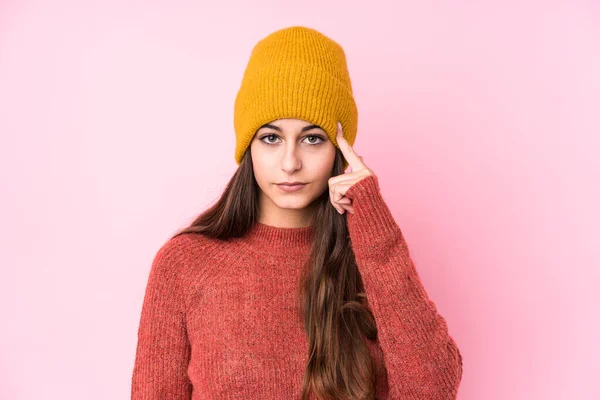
[[233, 26, 358, 170]]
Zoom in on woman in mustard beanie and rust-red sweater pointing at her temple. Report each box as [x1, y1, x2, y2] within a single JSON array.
[[132, 26, 462, 400]]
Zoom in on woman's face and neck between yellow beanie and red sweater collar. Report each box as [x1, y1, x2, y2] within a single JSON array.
[[250, 118, 336, 226]]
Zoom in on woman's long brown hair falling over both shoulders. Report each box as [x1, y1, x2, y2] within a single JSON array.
[[174, 148, 377, 400]]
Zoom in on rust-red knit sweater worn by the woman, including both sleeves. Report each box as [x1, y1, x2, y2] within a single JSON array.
[[131, 175, 462, 400]]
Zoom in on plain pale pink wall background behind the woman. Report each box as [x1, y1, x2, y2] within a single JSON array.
[[0, 0, 600, 400]]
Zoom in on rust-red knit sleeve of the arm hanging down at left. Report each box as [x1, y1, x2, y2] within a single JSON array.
[[131, 238, 192, 400]]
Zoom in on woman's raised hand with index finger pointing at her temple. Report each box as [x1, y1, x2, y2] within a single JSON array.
[[329, 122, 374, 214]]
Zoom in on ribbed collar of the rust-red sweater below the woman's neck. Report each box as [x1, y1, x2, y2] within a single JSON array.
[[244, 221, 314, 255]]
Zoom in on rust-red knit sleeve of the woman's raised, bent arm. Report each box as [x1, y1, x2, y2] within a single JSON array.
[[346, 175, 463, 400]]
